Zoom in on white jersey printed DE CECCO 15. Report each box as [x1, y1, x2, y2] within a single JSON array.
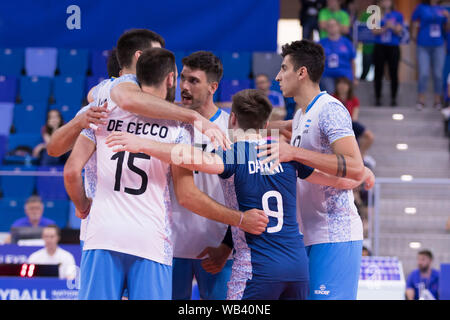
[[83, 75, 191, 265]]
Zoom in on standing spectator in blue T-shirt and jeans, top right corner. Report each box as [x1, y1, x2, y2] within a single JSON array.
[[411, 0, 449, 110]]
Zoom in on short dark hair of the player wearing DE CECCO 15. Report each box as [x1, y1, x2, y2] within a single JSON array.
[[136, 48, 176, 86]]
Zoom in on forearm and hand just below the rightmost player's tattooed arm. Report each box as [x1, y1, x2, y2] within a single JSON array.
[[305, 167, 375, 190]]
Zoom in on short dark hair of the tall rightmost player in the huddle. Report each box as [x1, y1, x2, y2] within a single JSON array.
[[281, 40, 325, 83]]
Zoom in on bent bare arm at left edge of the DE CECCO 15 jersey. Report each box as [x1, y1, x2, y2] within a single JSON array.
[[64, 135, 96, 219]]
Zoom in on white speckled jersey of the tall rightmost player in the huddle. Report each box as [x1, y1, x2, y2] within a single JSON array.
[[291, 92, 363, 246]]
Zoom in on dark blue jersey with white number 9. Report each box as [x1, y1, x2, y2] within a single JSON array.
[[220, 141, 314, 282]]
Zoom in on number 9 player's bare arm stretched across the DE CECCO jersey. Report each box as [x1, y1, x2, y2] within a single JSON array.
[[106, 132, 224, 174]]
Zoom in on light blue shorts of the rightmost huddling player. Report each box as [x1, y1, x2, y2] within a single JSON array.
[[306, 241, 362, 300]]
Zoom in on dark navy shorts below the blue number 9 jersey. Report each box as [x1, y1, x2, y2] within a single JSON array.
[[242, 279, 309, 300]]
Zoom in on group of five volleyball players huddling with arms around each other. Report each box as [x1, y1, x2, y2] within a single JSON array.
[[48, 29, 374, 300]]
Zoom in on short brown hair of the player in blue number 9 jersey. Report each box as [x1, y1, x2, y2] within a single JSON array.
[[231, 89, 272, 130]]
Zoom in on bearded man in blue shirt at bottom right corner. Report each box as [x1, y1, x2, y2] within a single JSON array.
[[406, 250, 439, 300]]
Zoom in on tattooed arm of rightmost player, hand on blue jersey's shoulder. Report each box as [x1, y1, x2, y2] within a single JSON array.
[[257, 136, 365, 181]]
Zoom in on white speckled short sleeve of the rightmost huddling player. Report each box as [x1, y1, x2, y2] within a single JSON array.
[[319, 102, 355, 144]]
